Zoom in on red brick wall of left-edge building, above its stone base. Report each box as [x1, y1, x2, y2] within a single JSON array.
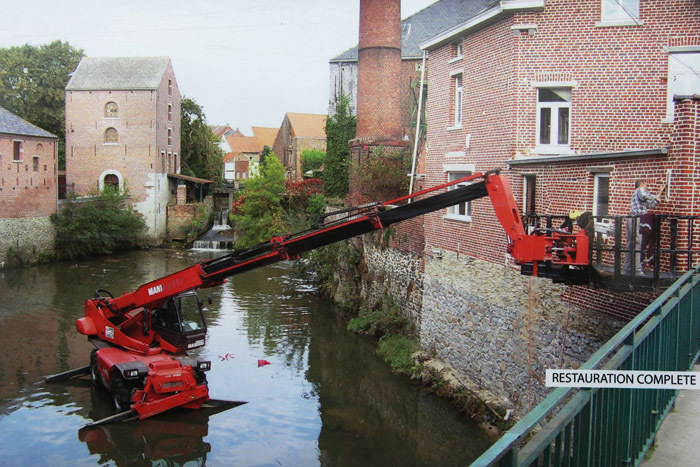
[[0, 135, 58, 218]]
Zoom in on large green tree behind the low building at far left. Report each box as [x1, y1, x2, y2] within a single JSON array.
[[0, 41, 85, 139]]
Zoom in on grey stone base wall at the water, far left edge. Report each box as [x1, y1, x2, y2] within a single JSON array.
[[0, 216, 55, 269]]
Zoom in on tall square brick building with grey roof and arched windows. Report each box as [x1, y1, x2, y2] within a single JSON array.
[[66, 57, 181, 238]]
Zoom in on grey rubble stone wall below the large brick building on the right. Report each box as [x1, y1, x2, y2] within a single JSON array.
[[419, 252, 624, 415]]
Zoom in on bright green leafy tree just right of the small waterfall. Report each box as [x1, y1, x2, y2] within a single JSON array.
[[231, 152, 286, 248]]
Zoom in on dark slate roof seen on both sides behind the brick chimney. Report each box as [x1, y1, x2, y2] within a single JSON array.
[[331, 0, 490, 62]]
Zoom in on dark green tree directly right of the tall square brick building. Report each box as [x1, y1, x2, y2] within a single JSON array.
[[180, 97, 224, 181]]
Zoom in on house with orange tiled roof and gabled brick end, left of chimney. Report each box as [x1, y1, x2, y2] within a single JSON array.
[[272, 112, 327, 181]]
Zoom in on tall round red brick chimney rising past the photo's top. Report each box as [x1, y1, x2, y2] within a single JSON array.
[[348, 0, 408, 205]]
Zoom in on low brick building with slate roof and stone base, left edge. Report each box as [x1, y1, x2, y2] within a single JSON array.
[[0, 107, 58, 268]]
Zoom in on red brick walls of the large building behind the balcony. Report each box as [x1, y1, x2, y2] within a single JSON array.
[[425, 0, 700, 317]]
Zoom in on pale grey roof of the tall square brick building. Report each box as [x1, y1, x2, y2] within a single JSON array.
[[66, 57, 170, 91]]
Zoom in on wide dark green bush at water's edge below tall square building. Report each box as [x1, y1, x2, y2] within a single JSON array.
[[51, 186, 147, 259]]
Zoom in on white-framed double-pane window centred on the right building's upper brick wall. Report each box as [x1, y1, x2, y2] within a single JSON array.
[[535, 87, 571, 154]]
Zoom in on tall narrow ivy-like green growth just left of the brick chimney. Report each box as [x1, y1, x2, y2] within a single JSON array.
[[323, 95, 357, 198]]
